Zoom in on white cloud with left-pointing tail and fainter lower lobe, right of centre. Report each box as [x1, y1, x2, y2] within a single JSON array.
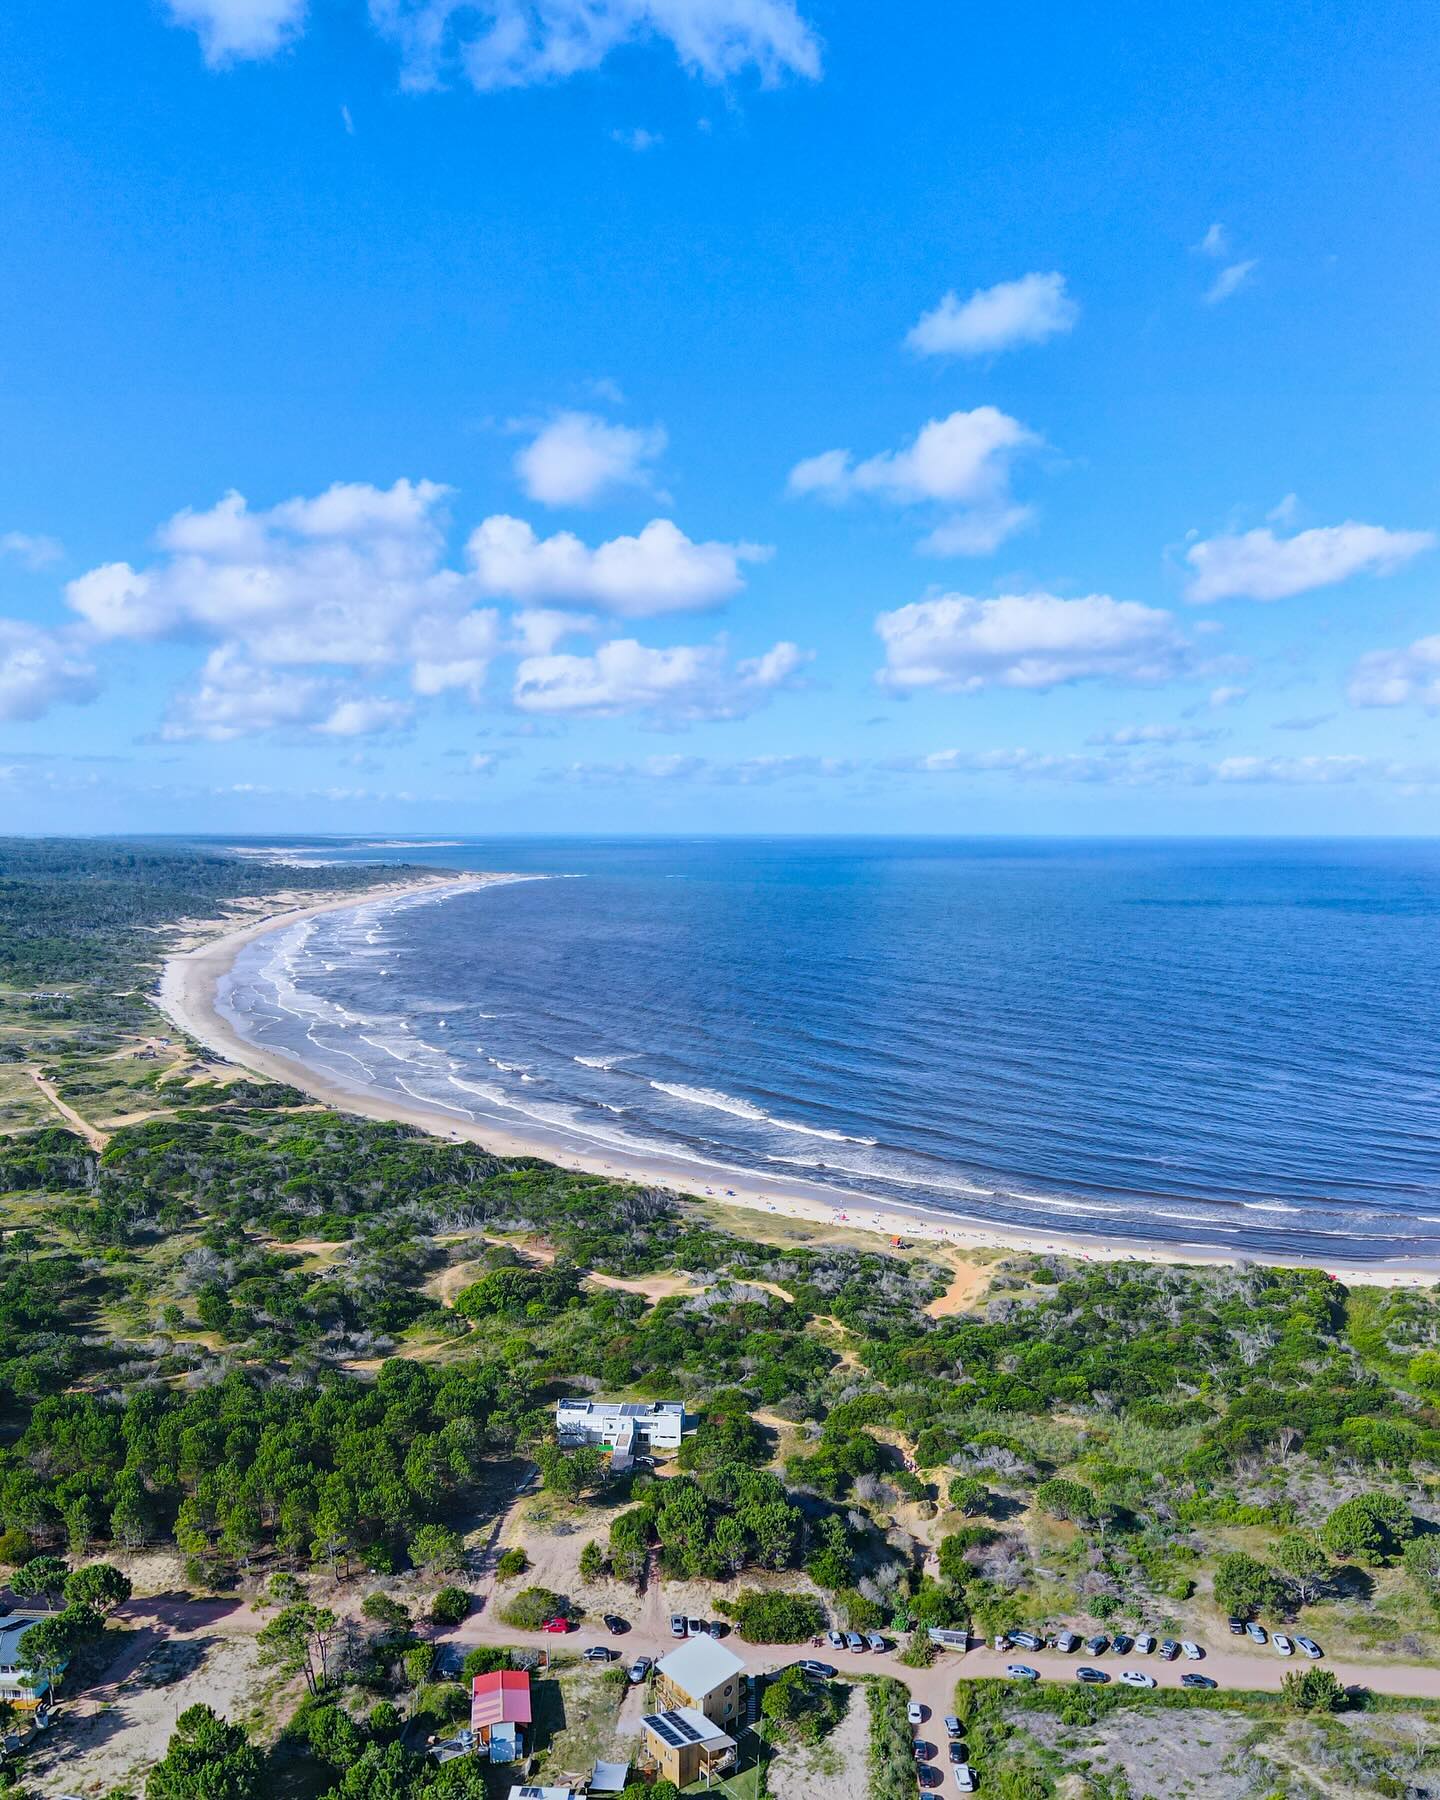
[[788, 407, 1040, 556]]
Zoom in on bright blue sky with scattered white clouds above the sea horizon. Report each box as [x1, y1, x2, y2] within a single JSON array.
[[0, 0, 1440, 835]]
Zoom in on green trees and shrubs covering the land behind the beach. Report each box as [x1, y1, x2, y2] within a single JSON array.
[[0, 846, 1440, 1796]]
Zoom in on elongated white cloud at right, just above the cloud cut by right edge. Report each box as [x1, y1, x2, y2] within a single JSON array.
[[1184, 520, 1436, 605]]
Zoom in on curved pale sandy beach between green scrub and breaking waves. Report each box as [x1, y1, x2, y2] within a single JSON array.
[[153, 873, 1440, 1287]]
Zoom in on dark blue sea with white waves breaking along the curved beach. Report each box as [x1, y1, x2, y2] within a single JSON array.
[[216, 841, 1440, 1262]]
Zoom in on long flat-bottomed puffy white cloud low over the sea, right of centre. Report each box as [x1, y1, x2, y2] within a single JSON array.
[[875, 594, 1184, 693]]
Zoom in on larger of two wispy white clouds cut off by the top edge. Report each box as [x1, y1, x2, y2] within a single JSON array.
[[369, 0, 821, 92]]
